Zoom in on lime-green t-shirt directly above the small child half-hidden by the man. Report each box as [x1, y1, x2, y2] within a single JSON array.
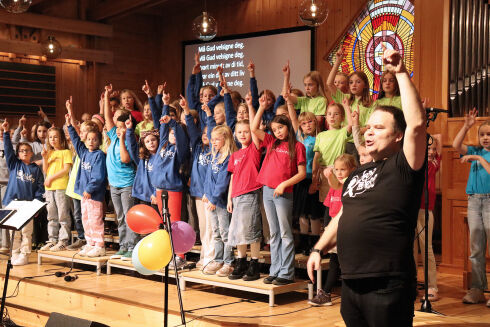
[[313, 127, 348, 166]]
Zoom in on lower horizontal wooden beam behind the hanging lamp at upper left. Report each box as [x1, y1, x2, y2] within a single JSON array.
[[0, 40, 114, 64]]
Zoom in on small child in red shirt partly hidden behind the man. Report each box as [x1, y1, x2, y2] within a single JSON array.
[[308, 154, 357, 306]]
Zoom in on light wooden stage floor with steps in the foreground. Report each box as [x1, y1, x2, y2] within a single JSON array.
[[0, 255, 490, 327]]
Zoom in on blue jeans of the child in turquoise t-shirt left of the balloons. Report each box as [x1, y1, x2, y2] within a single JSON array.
[[111, 185, 140, 251]]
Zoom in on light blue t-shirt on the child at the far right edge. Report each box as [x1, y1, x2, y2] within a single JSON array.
[[466, 146, 490, 194]]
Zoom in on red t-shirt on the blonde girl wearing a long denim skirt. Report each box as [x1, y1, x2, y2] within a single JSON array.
[[228, 143, 262, 198]]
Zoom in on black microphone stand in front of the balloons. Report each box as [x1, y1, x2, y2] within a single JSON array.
[[160, 191, 187, 327]]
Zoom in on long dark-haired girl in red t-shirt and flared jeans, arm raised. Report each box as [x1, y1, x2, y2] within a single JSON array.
[[251, 98, 306, 285]]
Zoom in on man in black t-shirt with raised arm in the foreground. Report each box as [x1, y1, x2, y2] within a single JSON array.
[[308, 46, 426, 327]]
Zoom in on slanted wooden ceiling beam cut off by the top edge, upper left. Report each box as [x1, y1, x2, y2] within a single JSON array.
[[88, 0, 168, 21]]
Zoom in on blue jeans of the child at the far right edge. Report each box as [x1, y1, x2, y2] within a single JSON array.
[[468, 194, 490, 290]]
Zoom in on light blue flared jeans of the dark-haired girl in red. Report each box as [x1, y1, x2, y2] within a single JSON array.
[[263, 186, 294, 280]]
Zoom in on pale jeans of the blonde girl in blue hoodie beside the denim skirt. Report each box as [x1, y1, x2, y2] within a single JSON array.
[[206, 206, 233, 265]]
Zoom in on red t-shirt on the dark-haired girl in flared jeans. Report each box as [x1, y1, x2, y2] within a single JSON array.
[[257, 134, 306, 193]]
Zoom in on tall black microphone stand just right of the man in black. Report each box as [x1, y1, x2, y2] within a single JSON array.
[[415, 108, 444, 316]]
